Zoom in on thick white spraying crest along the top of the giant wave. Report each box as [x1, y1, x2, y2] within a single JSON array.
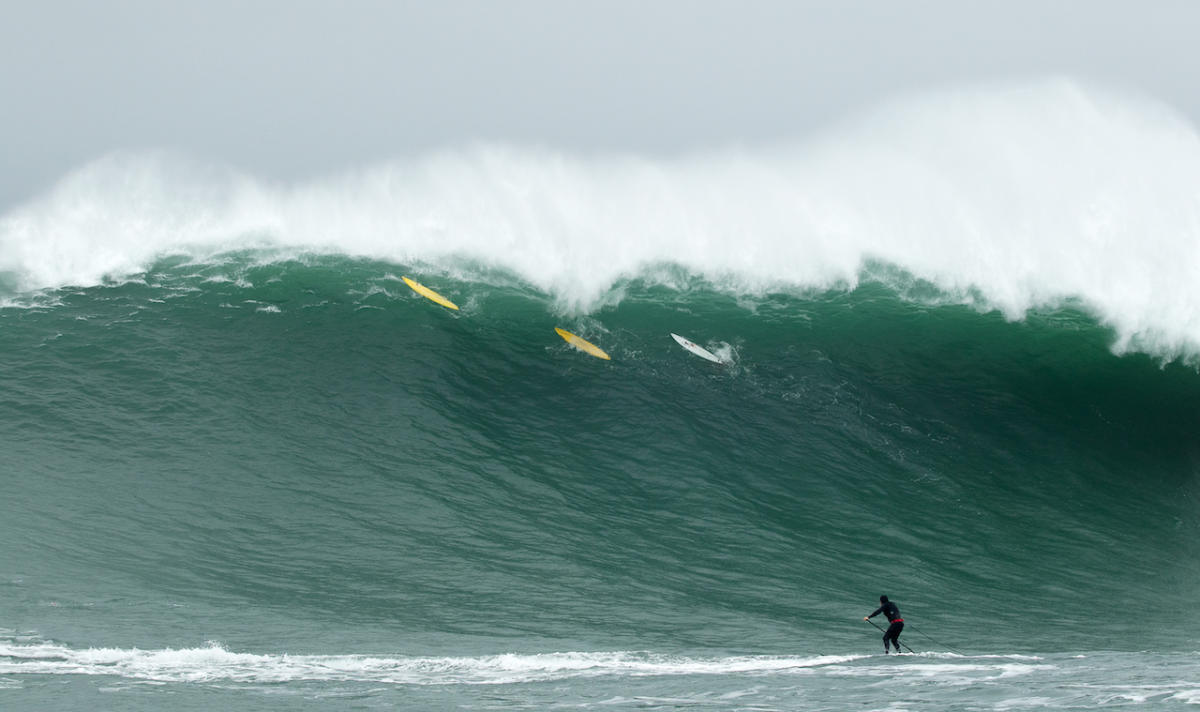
[[0, 79, 1200, 357]]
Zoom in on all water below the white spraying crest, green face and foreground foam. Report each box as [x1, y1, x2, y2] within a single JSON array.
[[0, 252, 1200, 710]]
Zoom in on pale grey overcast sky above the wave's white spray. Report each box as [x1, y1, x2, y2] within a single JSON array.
[[0, 0, 1200, 210]]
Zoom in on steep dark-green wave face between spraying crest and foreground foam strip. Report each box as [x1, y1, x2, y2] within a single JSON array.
[[0, 255, 1200, 648]]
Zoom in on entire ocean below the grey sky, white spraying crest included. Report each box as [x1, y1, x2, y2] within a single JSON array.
[[0, 80, 1200, 711]]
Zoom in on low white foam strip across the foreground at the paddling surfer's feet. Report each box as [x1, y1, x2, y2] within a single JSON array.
[[0, 640, 1200, 710]]
